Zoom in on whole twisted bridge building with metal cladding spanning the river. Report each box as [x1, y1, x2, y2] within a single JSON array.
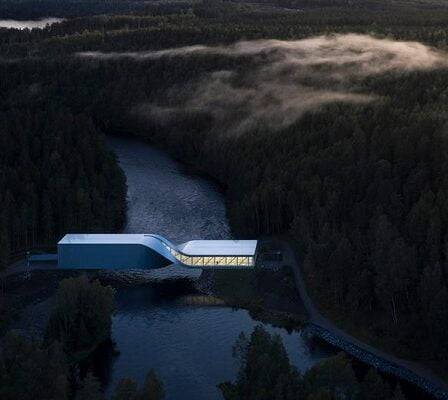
[[58, 234, 257, 269]]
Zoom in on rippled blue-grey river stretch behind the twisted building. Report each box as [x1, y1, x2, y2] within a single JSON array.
[[110, 137, 230, 243]]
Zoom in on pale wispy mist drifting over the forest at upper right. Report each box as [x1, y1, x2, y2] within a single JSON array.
[[78, 34, 448, 133]]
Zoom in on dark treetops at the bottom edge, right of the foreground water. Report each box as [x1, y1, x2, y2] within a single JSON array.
[[218, 326, 405, 400]]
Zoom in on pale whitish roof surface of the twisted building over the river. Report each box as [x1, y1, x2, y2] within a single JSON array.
[[58, 233, 257, 256]]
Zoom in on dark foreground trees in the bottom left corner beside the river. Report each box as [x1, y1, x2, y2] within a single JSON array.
[[0, 275, 165, 400]]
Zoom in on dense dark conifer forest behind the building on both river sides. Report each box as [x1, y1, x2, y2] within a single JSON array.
[[0, 0, 448, 386]]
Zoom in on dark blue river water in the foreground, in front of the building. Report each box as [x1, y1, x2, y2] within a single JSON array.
[[101, 285, 330, 400]]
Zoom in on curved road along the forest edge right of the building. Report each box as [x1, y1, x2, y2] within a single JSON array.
[[283, 240, 448, 399]]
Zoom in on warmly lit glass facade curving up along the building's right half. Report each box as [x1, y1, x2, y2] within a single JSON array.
[[161, 242, 254, 268]]
